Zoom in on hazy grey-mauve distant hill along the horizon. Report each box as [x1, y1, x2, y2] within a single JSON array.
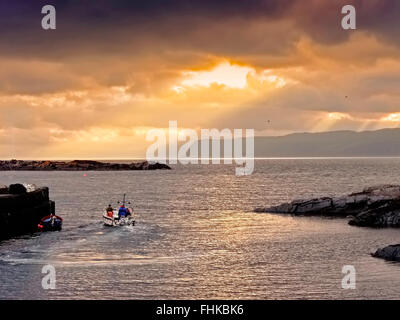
[[188, 129, 400, 157]]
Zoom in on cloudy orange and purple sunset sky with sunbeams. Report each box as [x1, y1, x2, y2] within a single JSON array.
[[0, 0, 400, 159]]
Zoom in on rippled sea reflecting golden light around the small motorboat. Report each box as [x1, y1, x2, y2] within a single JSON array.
[[0, 159, 400, 299]]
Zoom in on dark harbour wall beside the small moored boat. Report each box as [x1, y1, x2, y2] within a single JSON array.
[[0, 184, 55, 240]]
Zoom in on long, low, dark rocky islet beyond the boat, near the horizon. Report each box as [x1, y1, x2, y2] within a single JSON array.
[[0, 160, 171, 171]]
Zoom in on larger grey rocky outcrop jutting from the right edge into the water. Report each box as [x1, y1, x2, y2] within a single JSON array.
[[255, 185, 400, 228]]
